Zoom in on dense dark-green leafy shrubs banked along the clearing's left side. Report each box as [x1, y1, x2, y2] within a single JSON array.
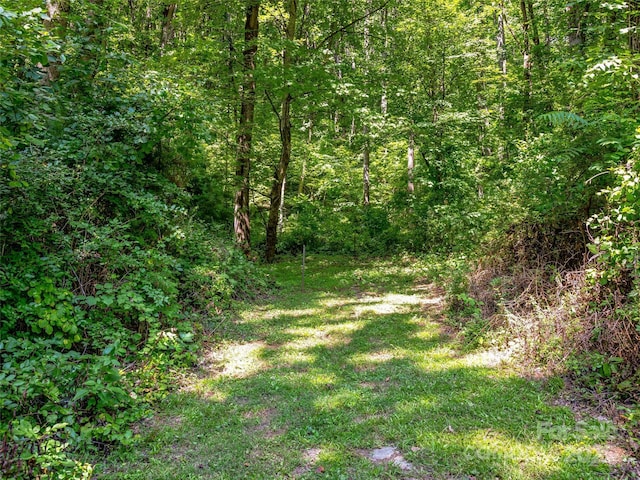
[[0, 4, 260, 478]]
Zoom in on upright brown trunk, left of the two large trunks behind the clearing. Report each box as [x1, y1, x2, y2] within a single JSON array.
[[233, 0, 260, 255]]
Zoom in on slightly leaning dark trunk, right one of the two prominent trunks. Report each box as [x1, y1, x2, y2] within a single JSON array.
[[266, 0, 298, 263]]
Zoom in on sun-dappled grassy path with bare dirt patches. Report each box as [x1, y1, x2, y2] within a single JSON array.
[[97, 256, 623, 480]]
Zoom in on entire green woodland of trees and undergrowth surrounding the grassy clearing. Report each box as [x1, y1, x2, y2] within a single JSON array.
[[0, 0, 640, 478]]
